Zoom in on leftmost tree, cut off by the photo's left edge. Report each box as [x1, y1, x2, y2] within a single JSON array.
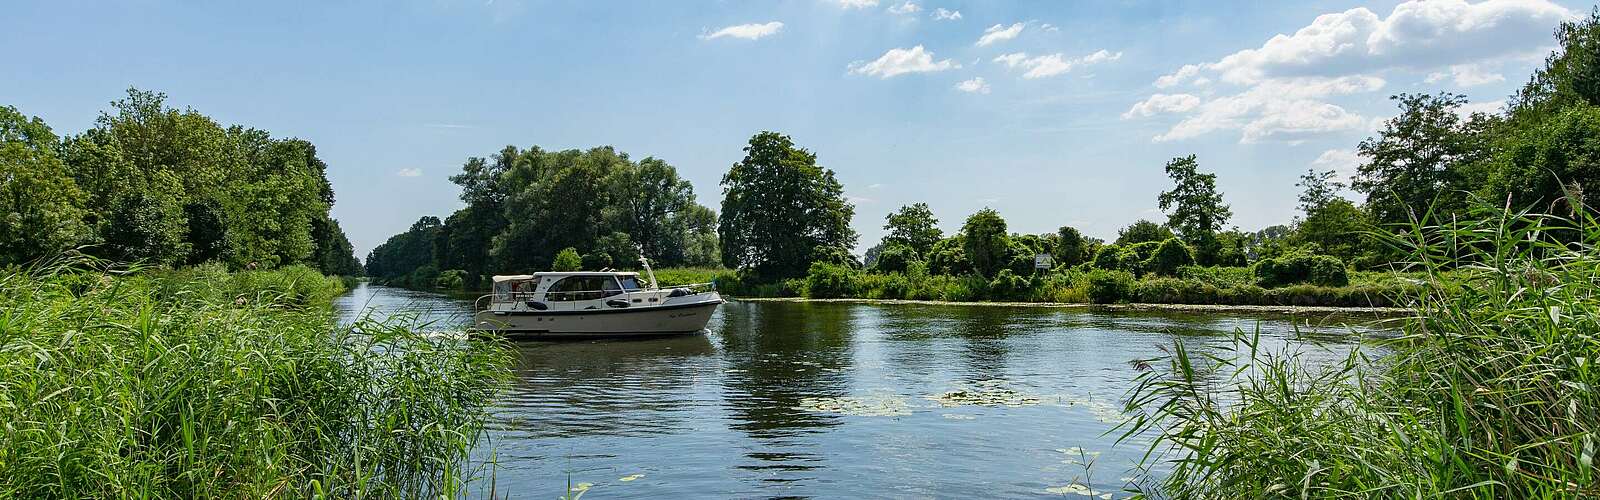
[[0, 106, 90, 266]]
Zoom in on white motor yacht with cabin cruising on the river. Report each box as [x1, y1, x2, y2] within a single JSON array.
[[472, 264, 723, 338]]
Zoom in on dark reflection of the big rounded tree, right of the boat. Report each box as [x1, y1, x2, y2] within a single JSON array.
[[718, 303, 858, 482]]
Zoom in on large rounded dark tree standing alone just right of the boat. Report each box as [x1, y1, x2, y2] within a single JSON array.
[[717, 131, 856, 279]]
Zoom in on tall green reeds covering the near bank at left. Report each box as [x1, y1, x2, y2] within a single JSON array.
[[0, 260, 506, 498]]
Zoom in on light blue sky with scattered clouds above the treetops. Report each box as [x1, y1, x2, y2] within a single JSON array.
[[0, 0, 1590, 256]]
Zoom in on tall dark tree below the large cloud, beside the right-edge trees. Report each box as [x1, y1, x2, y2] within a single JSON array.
[[1352, 93, 1490, 224]]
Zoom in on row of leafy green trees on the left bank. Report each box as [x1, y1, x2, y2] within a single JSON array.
[[0, 88, 362, 276]]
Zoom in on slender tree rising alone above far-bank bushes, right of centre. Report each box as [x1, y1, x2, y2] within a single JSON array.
[[1157, 154, 1234, 244]]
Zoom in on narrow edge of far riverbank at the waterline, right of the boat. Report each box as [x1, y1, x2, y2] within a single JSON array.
[[731, 296, 1411, 317]]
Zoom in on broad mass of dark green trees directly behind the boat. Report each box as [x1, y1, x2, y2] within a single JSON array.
[[366, 146, 720, 290]]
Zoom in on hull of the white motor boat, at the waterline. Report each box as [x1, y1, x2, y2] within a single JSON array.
[[472, 300, 722, 338]]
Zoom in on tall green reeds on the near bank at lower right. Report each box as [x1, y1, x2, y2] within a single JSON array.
[[1123, 201, 1600, 498]]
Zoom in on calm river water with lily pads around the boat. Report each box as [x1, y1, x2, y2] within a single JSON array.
[[338, 284, 1360, 498]]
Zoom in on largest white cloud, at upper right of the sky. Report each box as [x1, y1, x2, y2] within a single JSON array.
[[1125, 0, 1573, 143]]
